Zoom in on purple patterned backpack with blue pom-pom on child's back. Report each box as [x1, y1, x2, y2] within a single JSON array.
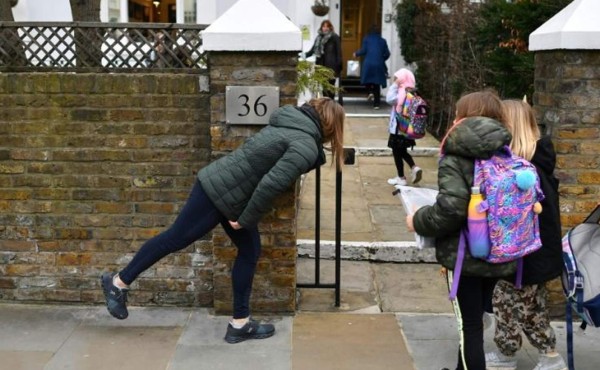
[[450, 146, 544, 299]]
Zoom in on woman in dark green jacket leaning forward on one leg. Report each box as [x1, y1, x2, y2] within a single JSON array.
[[101, 98, 345, 343]]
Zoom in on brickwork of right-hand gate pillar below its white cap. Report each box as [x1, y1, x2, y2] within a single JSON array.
[[534, 50, 600, 315]]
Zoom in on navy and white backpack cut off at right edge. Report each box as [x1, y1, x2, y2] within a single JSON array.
[[562, 205, 600, 370]]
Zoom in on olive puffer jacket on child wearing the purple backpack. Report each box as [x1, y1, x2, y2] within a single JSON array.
[[413, 117, 516, 277]]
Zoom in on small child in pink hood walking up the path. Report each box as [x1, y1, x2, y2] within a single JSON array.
[[385, 68, 423, 185]]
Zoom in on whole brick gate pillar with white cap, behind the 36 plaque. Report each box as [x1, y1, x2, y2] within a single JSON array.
[[203, 0, 301, 314]]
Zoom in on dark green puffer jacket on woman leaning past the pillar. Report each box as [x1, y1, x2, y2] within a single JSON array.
[[198, 105, 325, 228]]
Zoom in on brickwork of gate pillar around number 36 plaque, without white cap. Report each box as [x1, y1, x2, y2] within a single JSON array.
[[209, 52, 298, 314]]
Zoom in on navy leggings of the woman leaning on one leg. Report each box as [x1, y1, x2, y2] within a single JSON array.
[[119, 181, 261, 319]]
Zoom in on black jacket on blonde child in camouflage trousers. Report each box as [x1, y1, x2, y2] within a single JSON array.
[[523, 137, 563, 285]]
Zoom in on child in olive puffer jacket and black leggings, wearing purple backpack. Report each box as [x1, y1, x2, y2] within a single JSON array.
[[406, 91, 516, 370]]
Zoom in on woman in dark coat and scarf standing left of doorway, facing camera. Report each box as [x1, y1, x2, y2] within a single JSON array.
[[306, 19, 342, 103]]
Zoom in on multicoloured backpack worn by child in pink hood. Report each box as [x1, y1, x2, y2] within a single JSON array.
[[396, 89, 429, 139]]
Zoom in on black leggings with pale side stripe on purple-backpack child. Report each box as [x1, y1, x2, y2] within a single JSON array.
[[448, 271, 497, 370]]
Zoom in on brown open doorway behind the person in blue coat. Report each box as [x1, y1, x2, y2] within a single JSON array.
[[340, 0, 382, 79]]
